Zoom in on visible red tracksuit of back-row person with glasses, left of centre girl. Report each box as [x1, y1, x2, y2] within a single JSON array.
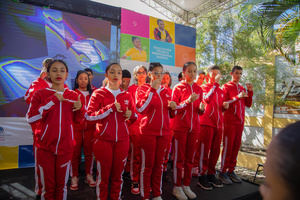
[[126, 84, 142, 182]]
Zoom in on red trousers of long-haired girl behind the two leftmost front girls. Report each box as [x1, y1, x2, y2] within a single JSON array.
[[71, 129, 95, 177]]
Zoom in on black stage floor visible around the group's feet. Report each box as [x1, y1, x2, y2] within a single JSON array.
[[0, 168, 261, 200]]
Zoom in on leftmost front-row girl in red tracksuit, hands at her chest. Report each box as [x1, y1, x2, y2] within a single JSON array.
[[27, 60, 84, 200]]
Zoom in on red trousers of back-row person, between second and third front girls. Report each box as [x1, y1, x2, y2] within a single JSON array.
[[128, 134, 141, 182]]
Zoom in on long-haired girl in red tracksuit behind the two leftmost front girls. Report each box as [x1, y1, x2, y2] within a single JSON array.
[[70, 70, 96, 190]]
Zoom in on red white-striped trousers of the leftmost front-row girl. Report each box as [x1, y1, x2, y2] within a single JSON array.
[[36, 148, 72, 200]]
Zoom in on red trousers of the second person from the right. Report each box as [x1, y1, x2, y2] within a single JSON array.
[[197, 125, 223, 175]]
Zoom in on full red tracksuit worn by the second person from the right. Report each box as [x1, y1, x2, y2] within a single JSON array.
[[197, 83, 224, 175]]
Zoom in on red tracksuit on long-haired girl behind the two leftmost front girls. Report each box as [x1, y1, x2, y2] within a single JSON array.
[[71, 89, 96, 177]]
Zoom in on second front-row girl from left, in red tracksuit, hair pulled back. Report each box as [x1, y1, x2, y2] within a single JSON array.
[[86, 63, 136, 200]]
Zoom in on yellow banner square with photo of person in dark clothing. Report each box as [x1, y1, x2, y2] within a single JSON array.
[[149, 17, 175, 43]]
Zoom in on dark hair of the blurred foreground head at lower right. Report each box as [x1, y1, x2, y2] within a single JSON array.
[[271, 121, 300, 200]]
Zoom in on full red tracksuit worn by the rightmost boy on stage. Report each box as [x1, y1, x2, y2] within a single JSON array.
[[221, 81, 253, 173]]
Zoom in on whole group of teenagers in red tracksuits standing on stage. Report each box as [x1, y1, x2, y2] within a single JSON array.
[[25, 59, 253, 200]]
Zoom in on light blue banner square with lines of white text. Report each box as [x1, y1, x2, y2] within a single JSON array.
[[150, 39, 175, 66]]
